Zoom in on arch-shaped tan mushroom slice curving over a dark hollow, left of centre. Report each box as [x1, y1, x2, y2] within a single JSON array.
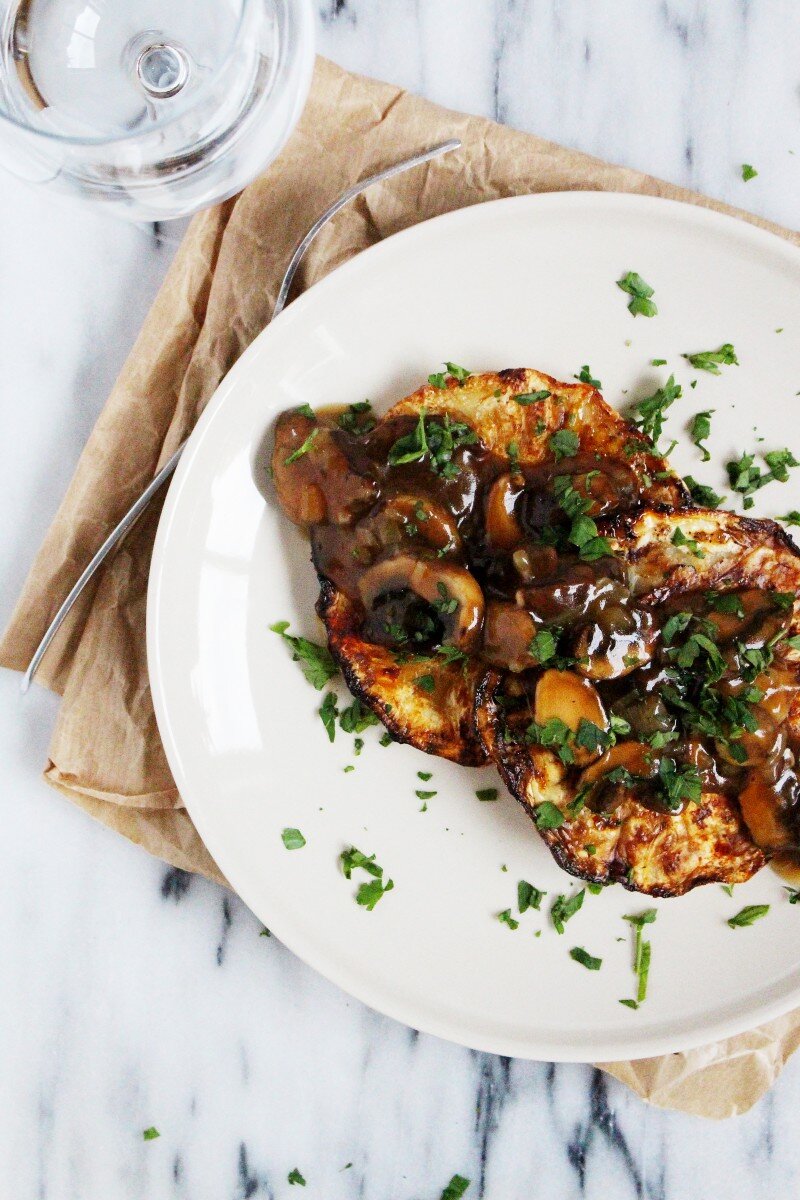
[[359, 554, 483, 650]]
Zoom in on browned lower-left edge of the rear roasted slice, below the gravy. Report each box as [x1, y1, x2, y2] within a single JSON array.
[[317, 578, 486, 767]]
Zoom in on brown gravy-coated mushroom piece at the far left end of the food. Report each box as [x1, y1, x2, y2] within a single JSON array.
[[272, 409, 377, 524]]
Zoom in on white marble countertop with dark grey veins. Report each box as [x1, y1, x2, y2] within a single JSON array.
[[0, 0, 800, 1200]]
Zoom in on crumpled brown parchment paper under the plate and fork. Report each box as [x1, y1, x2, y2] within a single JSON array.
[[0, 59, 800, 1117]]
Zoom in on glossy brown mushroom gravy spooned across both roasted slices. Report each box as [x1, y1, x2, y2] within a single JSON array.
[[273, 406, 800, 865]]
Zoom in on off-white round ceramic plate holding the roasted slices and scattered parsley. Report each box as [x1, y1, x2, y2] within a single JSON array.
[[148, 193, 800, 1060]]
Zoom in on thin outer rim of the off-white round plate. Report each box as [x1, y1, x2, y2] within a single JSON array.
[[146, 190, 800, 1062]]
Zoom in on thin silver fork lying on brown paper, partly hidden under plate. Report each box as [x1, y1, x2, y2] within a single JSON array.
[[20, 138, 461, 692]]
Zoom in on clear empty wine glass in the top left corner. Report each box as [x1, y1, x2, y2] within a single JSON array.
[[0, 0, 314, 221]]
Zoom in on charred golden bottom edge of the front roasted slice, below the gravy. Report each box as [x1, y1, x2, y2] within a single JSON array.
[[476, 671, 765, 896]]
